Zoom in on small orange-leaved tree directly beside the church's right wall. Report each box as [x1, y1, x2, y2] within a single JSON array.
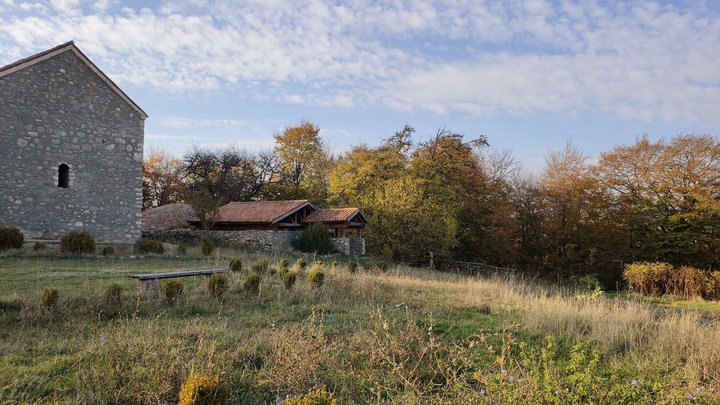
[[143, 149, 187, 209]]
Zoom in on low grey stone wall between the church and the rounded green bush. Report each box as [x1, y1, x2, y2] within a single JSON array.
[[142, 229, 300, 252]]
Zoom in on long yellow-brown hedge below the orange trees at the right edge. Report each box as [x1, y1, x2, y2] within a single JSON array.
[[623, 262, 720, 300]]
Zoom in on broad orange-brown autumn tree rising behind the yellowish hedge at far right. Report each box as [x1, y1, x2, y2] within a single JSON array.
[[597, 135, 720, 268]]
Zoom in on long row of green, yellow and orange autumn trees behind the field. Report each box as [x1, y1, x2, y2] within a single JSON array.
[[144, 122, 720, 284]]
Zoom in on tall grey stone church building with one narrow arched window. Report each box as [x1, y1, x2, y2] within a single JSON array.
[[0, 42, 147, 243]]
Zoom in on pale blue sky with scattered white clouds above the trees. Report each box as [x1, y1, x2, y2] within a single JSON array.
[[0, 0, 720, 172]]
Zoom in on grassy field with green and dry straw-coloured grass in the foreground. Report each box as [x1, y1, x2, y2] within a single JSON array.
[[0, 253, 720, 404]]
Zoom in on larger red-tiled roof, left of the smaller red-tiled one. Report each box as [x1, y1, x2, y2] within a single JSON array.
[[220, 200, 315, 224]]
